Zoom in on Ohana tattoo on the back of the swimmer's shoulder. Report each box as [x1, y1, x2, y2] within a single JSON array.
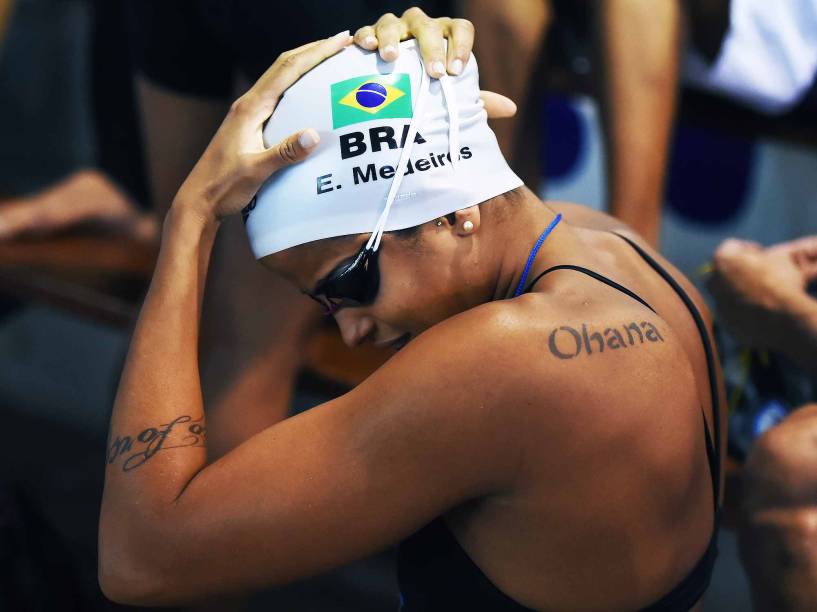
[[548, 321, 664, 359]]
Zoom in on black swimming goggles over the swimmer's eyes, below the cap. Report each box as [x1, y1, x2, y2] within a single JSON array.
[[304, 243, 380, 316]]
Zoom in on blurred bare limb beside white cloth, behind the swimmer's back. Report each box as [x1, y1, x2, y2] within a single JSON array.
[[596, 0, 682, 245]]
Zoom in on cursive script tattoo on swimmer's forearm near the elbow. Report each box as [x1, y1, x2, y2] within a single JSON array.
[[106, 415, 207, 472]]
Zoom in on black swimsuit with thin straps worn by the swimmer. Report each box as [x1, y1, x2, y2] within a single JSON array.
[[397, 234, 721, 612]]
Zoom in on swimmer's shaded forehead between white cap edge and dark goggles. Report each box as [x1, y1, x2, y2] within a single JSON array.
[[261, 234, 366, 289]]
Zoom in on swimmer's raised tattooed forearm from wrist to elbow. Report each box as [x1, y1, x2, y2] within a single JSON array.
[[100, 209, 217, 571]]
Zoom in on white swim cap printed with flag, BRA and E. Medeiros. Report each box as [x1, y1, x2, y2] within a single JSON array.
[[244, 40, 522, 259]]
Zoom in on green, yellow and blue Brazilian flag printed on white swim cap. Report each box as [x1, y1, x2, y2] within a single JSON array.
[[331, 73, 412, 130]]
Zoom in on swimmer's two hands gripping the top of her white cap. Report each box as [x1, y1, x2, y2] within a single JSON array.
[[174, 9, 516, 221]]
